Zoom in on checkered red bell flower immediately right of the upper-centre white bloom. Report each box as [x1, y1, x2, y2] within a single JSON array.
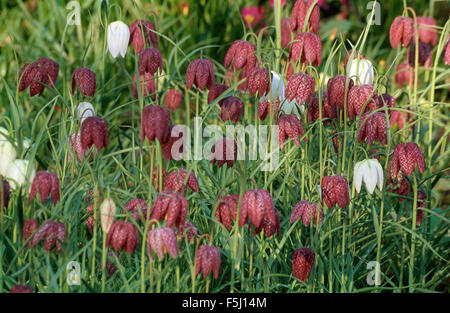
[[285, 72, 315, 105]]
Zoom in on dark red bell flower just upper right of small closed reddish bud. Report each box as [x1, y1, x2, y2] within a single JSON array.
[[186, 59, 215, 90]]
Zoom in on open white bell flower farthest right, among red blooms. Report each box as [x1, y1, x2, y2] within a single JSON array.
[[353, 159, 383, 194]]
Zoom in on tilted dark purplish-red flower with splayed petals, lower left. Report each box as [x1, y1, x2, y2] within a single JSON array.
[[31, 220, 66, 254]]
